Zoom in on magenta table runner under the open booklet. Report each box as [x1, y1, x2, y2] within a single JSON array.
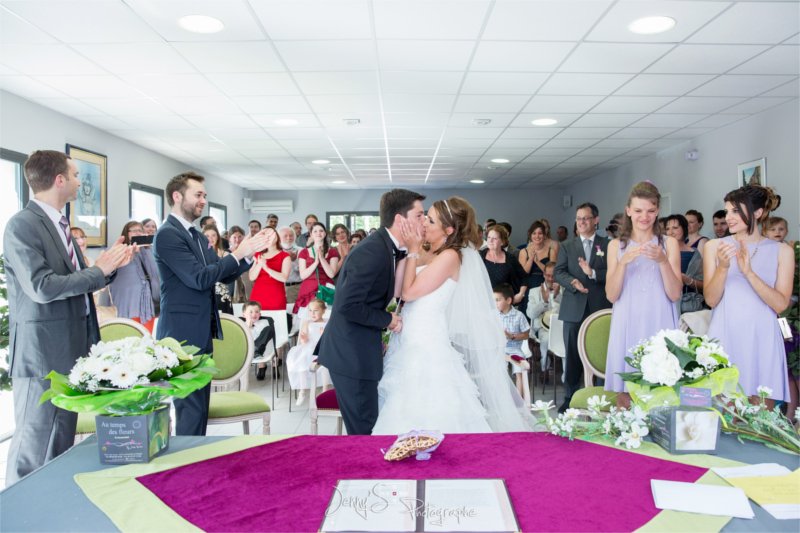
[[137, 433, 706, 531]]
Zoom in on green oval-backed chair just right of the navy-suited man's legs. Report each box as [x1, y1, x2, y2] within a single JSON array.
[[208, 314, 271, 435]]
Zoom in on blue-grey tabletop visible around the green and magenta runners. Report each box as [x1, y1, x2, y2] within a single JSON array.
[[0, 435, 800, 532]]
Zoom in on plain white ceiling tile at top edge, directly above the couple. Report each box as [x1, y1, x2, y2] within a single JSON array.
[[373, 0, 490, 40]]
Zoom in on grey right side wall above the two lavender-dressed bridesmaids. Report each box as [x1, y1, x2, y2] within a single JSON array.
[[561, 100, 800, 239]]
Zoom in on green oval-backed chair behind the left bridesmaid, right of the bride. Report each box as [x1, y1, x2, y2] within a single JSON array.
[[569, 309, 617, 410]]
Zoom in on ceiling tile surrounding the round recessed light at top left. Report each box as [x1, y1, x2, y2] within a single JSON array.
[[123, 0, 265, 42]]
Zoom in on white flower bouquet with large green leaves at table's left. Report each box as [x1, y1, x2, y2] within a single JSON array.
[[40, 336, 216, 415]]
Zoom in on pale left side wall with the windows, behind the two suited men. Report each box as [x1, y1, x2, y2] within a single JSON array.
[[0, 91, 247, 255]]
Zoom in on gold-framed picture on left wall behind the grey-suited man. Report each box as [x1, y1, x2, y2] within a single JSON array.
[[67, 144, 108, 248]]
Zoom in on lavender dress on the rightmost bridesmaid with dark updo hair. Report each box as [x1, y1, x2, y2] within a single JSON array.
[[708, 237, 789, 400]]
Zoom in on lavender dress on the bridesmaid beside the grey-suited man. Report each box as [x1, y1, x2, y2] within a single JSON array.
[[605, 237, 678, 392]]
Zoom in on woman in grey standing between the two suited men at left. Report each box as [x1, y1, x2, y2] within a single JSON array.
[[108, 220, 161, 334]]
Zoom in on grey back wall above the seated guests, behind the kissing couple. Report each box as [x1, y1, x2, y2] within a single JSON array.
[[250, 188, 562, 244]]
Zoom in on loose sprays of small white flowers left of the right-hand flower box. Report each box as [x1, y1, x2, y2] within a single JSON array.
[[531, 395, 650, 450]]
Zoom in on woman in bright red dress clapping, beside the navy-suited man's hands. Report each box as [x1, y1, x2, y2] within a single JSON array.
[[249, 227, 292, 311]]
